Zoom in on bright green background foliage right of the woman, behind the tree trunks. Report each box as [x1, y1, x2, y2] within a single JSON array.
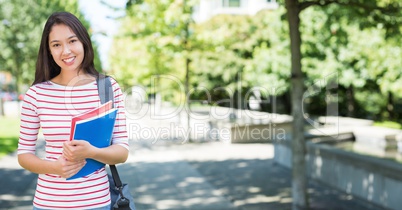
[[111, 0, 402, 118]]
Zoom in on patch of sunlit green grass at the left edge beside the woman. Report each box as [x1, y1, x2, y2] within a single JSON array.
[[0, 117, 20, 158]]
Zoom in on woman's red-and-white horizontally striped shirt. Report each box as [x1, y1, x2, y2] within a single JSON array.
[[18, 79, 129, 209]]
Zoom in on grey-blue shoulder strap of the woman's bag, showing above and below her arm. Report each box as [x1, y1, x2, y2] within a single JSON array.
[[96, 75, 123, 189]]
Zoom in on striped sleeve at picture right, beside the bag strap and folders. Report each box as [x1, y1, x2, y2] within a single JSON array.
[[111, 78, 129, 150]]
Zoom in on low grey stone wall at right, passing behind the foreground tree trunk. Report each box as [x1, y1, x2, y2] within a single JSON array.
[[274, 140, 402, 209]]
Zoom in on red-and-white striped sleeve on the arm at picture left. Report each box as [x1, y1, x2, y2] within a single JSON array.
[[17, 87, 40, 154]]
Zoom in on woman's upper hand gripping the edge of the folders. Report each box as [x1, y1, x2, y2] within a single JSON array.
[[63, 140, 93, 161]]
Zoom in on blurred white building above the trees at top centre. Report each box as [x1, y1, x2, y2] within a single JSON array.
[[194, 0, 278, 22]]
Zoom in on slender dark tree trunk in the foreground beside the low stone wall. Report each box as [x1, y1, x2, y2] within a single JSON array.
[[285, 0, 308, 210]]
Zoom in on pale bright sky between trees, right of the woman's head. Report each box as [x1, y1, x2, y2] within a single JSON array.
[[79, 0, 127, 70]]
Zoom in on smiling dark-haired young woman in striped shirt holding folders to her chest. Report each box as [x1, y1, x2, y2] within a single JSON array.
[[18, 12, 129, 209]]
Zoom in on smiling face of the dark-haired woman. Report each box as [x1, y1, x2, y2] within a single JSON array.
[[49, 24, 84, 71]]
